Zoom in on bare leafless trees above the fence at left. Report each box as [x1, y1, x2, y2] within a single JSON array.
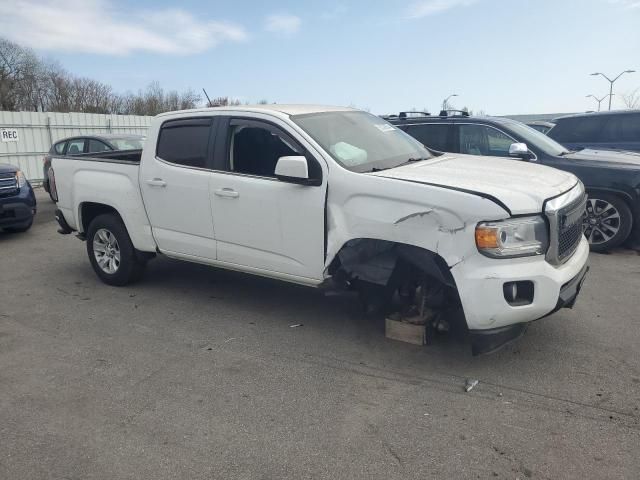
[[0, 38, 205, 115]]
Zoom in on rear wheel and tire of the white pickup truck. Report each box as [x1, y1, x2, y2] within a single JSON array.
[[87, 213, 145, 287]]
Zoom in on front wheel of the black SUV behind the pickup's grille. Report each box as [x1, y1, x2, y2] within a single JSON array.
[[582, 193, 633, 252]]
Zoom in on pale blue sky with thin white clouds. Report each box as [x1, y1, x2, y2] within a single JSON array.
[[0, 0, 640, 115]]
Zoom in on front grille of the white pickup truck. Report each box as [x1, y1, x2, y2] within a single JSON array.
[[547, 188, 587, 265]]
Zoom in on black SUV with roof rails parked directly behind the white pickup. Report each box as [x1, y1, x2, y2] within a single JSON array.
[[384, 112, 640, 252]]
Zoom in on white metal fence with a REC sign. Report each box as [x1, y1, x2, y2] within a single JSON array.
[[0, 111, 152, 183]]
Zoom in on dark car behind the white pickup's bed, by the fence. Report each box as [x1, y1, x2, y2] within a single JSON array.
[[42, 133, 145, 200]]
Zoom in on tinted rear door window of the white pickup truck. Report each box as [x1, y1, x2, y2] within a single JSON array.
[[156, 117, 213, 168]]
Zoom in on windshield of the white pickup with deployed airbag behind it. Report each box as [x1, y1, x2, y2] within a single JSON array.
[[291, 111, 433, 173]]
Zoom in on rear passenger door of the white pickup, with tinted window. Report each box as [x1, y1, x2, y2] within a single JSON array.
[[140, 117, 216, 260]]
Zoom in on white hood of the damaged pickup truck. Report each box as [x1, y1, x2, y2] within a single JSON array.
[[372, 153, 578, 215]]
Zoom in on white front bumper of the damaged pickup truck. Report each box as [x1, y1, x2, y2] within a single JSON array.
[[451, 238, 589, 344]]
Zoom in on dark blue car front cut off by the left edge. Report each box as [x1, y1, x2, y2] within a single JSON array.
[[0, 163, 36, 232]]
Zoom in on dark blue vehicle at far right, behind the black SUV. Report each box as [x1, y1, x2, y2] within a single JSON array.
[[546, 110, 640, 152]]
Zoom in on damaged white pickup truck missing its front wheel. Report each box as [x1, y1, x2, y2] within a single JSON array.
[[49, 105, 589, 353]]
